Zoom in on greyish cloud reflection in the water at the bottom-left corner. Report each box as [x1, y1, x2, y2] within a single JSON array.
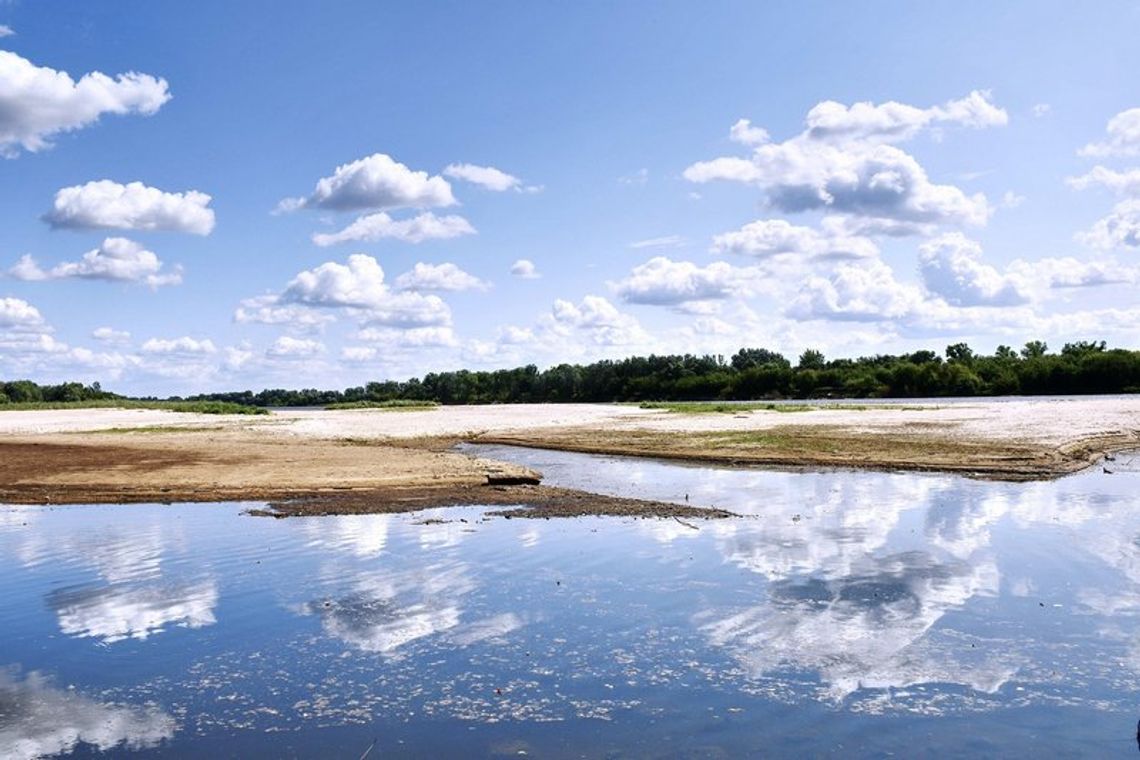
[[0, 669, 176, 759]]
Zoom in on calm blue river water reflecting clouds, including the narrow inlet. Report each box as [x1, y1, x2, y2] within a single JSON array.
[[0, 447, 1140, 759]]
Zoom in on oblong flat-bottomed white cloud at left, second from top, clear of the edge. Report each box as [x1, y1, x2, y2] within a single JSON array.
[[43, 180, 214, 235]]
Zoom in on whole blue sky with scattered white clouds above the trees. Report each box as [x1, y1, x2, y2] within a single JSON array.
[[0, 0, 1140, 393]]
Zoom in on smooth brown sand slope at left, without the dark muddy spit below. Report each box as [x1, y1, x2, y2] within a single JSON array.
[[0, 430, 539, 504]]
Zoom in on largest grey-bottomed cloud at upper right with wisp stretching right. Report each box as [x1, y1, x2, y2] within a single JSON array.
[[684, 92, 1007, 224]]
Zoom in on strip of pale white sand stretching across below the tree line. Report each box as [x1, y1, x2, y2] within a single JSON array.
[[0, 397, 1140, 444]]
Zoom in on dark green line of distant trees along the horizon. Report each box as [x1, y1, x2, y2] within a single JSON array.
[[0, 341, 1140, 407]]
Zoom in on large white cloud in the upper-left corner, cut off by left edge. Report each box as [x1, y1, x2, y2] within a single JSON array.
[[0, 50, 170, 158]]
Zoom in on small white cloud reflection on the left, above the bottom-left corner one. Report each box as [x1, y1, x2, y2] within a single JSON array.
[[47, 580, 218, 644]]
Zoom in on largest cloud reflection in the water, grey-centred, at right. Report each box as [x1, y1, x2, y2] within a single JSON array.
[[698, 551, 1016, 700]]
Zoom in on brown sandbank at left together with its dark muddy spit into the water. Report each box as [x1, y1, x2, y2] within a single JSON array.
[[0, 431, 732, 518]]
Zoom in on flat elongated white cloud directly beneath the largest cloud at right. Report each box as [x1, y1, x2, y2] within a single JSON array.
[[713, 219, 879, 259]]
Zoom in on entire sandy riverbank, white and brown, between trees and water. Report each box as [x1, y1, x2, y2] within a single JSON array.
[[0, 398, 1140, 516]]
